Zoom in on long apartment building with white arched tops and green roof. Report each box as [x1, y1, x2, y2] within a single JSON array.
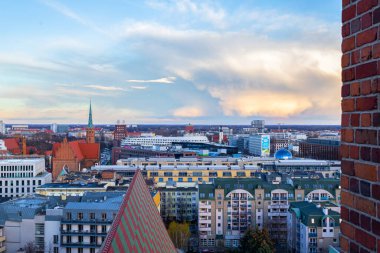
[[198, 177, 340, 252]]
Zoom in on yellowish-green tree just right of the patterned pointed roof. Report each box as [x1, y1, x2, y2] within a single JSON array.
[[168, 221, 191, 249]]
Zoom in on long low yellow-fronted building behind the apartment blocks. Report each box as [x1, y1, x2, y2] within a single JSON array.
[[91, 157, 340, 183]]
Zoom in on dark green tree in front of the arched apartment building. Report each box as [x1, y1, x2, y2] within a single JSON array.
[[239, 227, 275, 253]]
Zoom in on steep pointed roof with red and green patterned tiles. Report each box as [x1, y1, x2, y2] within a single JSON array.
[[100, 170, 176, 253]]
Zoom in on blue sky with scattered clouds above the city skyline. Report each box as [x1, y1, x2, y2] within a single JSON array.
[[0, 0, 341, 124]]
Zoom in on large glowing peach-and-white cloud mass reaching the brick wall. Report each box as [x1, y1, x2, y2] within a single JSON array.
[[116, 16, 340, 121]]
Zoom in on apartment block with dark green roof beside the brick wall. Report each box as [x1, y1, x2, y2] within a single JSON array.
[[287, 201, 341, 253]]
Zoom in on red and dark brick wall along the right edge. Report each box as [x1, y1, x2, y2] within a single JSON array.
[[341, 0, 380, 252]]
